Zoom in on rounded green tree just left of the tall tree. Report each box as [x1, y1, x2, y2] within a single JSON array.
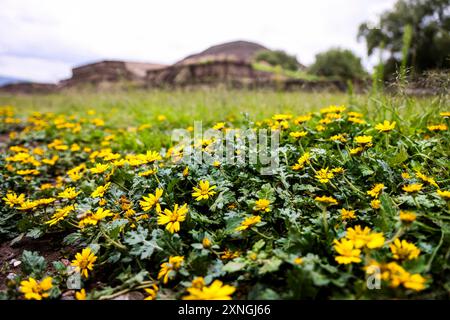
[[309, 48, 367, 80]]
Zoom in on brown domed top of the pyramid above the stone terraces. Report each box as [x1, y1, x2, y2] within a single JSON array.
[[175, 41, 268, 65]]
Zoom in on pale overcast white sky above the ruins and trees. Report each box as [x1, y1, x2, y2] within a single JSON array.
[[0, 0, 396, 82]]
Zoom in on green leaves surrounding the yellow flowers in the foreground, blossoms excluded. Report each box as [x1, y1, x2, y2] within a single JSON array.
[[0, 92, 450, 299]]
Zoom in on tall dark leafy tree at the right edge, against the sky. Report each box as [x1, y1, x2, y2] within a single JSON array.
[[358, 0, 450, 75]]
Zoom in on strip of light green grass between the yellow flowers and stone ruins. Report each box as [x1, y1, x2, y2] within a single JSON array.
[[0, 89, 448, 151]]
